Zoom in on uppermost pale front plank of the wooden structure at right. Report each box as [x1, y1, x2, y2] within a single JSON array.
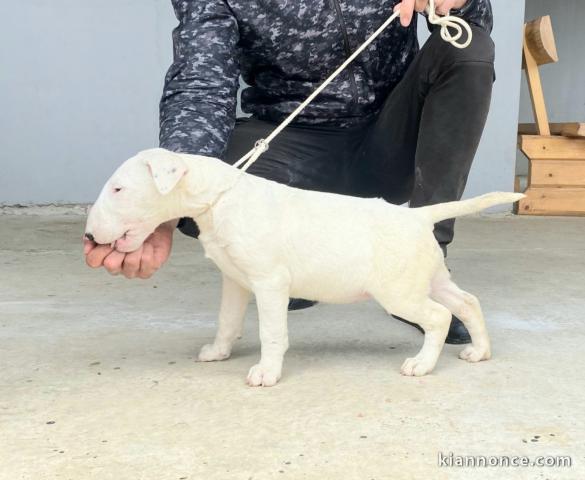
[[519, 135, 585, 160]]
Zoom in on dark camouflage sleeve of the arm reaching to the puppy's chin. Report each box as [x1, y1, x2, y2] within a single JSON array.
[[160, 0, 239, 157]]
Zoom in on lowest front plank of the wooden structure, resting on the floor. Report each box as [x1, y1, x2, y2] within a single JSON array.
[[518, 187, 585, 216]]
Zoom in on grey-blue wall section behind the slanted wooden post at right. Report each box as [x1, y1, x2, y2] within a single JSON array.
[[517, 0, 585, 174]]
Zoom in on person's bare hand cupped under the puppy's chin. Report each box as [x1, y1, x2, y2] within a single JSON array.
[[83, 220, 177, 279]]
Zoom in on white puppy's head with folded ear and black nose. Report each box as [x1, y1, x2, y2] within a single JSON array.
[[85, 149, 188, 252]]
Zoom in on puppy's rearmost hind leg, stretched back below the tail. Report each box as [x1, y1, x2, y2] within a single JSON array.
[[431, 267, 491, 362]]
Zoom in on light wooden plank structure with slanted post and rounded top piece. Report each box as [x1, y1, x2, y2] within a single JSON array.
[[516, 16, 585, 215]]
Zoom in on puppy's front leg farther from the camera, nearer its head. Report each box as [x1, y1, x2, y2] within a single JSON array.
[[199, 275, 250, 362]]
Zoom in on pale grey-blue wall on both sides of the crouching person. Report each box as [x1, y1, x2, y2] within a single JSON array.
[[0, 0, 524, 204]]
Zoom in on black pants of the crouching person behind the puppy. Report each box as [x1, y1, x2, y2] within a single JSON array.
[[180, 28, 494, 250]]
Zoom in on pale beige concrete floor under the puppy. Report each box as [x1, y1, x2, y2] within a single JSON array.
[[0, 215, 585, 480]]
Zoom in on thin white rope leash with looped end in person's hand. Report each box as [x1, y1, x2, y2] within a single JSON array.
[[234, 0, 473, 172]]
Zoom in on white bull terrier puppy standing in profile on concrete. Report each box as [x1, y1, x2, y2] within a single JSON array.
[[86, 149, 523, 386]]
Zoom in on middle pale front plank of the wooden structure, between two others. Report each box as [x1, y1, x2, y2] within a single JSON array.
[[530, 160, 585, 187]]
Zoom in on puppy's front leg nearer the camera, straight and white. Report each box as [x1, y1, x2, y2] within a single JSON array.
[[247, 280, 289, 387]]
